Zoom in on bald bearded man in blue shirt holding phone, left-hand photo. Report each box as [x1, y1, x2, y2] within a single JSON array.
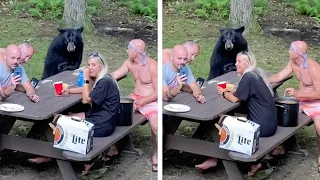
[[0, 44, 39, 102]]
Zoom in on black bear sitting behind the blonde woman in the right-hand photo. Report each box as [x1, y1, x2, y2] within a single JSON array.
[[208, 26, 248, 80]]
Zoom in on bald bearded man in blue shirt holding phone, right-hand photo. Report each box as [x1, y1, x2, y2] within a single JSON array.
[[162, 45, 205, 103]]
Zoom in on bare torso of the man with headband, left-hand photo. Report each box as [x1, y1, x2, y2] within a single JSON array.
[[127, 57, 157, 97]]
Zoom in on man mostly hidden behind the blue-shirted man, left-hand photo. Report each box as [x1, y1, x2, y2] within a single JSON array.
[[0, 42, 34, 64]]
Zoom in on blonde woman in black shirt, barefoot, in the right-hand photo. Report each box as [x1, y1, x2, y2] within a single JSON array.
[[196, 52, 278, 176]]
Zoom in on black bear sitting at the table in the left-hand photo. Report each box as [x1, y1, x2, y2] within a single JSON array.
[[41, 27, 83, 79]]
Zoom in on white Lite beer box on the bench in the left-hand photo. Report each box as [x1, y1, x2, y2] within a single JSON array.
[[53, 115, 94, 154]]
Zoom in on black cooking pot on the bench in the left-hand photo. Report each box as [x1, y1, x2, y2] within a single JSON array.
[[117, 98, 134, 126]]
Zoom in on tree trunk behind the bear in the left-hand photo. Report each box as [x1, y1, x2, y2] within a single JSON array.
[[63, 0, 87, 28]]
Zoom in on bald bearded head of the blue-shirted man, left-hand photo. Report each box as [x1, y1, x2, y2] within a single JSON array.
[[5, 44, 21, 69]]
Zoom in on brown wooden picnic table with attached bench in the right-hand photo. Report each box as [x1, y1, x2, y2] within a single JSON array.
[[163, 72, 311, 179]]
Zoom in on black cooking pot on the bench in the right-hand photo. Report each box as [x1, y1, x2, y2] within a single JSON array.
[[275, 97, 299, 127]]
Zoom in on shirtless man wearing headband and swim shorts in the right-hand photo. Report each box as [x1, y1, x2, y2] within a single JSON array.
[[269, 41, 320, 172]]
